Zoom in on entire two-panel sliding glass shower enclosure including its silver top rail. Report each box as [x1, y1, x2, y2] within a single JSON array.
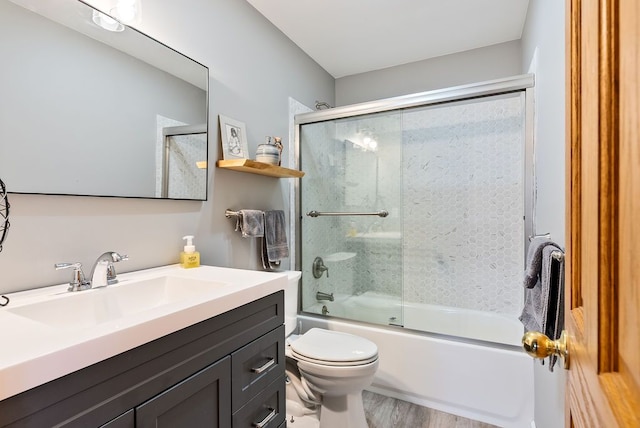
[[296, 78, 535, 346]]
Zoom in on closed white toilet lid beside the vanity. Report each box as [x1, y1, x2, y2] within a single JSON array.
[[291, 328, 378, 365]]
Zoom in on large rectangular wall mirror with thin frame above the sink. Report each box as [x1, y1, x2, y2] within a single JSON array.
[[0, 0, 209, 200]]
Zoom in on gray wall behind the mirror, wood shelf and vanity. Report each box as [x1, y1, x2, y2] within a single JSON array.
[[0, 0, 334, 293]]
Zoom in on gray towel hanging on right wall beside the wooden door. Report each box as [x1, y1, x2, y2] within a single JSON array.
[[519, 238, 564, 371]]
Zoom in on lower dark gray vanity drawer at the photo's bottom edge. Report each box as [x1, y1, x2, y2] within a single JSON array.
[[233, 375, 286, 428]]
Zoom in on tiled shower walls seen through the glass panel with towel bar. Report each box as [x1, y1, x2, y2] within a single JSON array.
[[300, 114, 402, 308]]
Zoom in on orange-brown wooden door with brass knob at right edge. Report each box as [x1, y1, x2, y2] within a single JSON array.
[[566, 0, 640, 428]]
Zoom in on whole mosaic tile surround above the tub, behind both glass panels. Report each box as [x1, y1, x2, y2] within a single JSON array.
[[300, 93, 525, 342]]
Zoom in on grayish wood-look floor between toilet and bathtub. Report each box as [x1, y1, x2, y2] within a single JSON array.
[[362, 391, 495, 428]]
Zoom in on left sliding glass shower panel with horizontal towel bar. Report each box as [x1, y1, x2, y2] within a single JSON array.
[[300, 112, 403, 325]]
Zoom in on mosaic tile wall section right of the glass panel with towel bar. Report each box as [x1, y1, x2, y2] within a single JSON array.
[[402, 95, 524, 315]]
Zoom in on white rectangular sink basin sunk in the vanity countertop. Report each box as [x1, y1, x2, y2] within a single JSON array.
[[7, 276, 228, 328]]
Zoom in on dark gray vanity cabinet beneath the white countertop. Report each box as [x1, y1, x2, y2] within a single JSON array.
[[0, 291, 285, 428]]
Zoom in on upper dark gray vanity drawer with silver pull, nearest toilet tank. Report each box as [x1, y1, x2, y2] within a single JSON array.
[[231, 325, 285, 412]]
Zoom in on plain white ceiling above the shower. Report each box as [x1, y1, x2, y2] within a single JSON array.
[[247, 0, 529, 78]]
